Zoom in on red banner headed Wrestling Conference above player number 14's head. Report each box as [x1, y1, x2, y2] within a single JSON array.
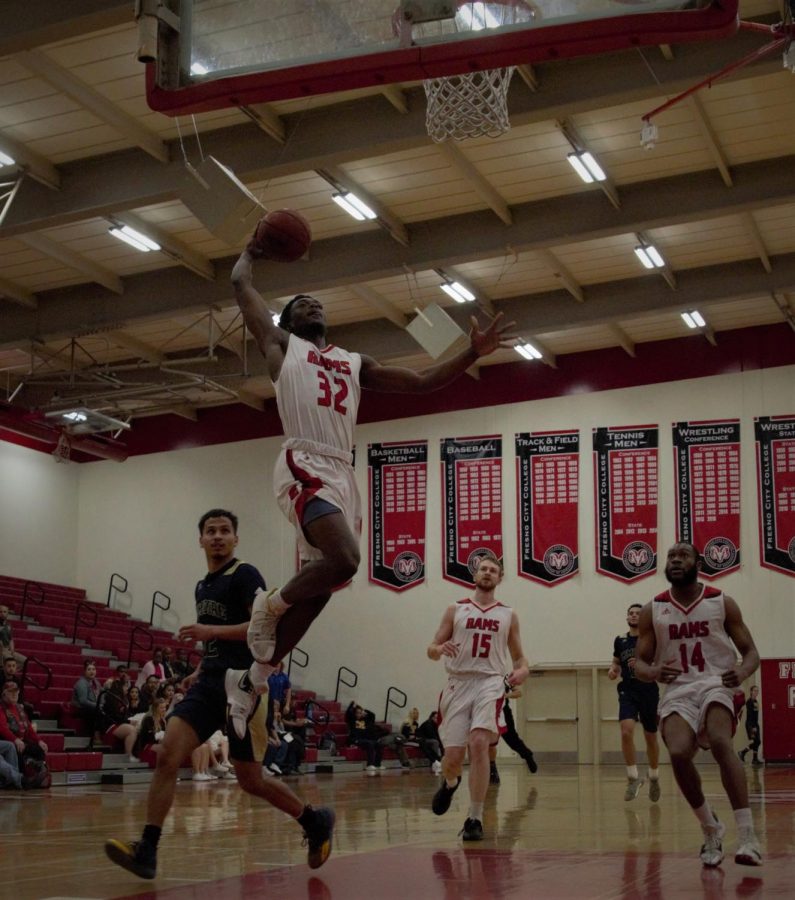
[[673, 419, 740, 578]]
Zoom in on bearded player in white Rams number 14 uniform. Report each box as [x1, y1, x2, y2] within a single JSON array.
[[635, 542, 762, 867]]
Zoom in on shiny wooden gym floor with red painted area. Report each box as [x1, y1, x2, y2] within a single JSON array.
[[0, 760, 795, 900]]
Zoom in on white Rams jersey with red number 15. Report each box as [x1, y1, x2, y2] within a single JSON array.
[[444, 600, 513, 677]]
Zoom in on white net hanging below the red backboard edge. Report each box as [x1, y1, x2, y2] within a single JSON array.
[[423, 66, 515, 144]]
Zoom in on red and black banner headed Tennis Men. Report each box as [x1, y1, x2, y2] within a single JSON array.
[[593, 425, 659, 583]]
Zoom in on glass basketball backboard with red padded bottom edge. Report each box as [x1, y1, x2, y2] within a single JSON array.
[[145, 0, 738, 115]]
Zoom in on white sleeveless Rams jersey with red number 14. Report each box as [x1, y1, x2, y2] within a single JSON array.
[[651, 585, 737, 696]]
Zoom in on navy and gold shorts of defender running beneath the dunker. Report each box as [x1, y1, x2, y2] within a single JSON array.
[[171, 671, 268, 762]]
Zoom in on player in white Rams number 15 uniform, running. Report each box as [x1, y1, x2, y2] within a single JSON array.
[[428, 555, 530, 841]]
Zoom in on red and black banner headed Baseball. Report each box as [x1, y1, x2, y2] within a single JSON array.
[[441, 435, 502, 587]]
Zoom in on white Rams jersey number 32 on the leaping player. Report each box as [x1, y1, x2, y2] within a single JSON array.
[[275, 334, 362, 461]]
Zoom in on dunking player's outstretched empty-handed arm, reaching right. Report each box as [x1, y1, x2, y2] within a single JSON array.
[[360, 313, 514, 394]]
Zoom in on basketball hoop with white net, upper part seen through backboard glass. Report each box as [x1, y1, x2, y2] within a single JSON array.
[[403, 0, 534, 143]]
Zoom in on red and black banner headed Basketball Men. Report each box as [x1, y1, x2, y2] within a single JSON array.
[[367, 441, 428, 591]]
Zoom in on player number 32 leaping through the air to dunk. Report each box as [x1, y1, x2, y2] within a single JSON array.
[[226, 242, 510, 733]]
